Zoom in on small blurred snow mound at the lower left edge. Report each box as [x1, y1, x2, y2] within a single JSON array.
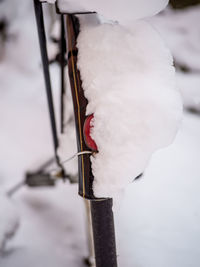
[[0, 193, 19, 252]]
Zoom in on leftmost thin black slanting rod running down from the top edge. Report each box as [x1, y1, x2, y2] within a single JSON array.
[[33, 0, 58, 157]]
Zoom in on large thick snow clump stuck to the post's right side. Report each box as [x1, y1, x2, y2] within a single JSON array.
[[77, 15, 182, 197]]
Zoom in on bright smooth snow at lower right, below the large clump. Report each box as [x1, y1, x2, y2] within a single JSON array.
[[116, 113, 200, 267]]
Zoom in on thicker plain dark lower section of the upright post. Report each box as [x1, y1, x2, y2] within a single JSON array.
[[91, 199, 117, 267]]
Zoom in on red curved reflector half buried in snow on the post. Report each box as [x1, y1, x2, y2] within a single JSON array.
[[83, 114, 98, 151]]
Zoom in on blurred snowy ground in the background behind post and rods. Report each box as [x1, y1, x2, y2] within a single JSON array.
[[0, 0, 200, 267]]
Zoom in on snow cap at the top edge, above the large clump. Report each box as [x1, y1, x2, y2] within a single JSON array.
[[56, 0, 168, 23]]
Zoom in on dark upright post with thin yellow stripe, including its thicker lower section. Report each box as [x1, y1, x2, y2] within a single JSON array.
[[66, 15, 117, 267]]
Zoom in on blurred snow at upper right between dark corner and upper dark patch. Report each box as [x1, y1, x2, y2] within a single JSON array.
[[150, 6, 200, 71]]
